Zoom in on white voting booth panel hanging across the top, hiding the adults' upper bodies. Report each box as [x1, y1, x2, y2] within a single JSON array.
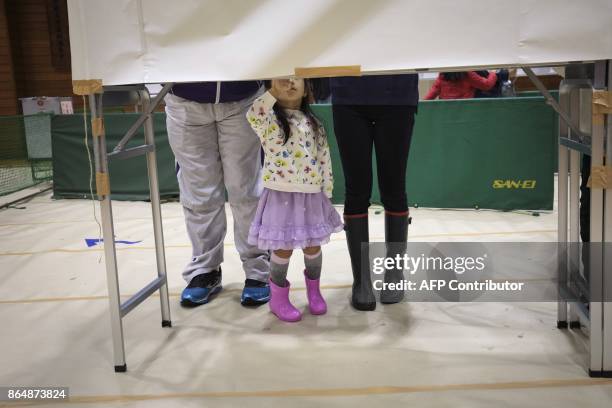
[[68, 0, 612, 86]]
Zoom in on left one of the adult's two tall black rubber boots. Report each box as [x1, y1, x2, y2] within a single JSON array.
[[344, 214, 376, 311]]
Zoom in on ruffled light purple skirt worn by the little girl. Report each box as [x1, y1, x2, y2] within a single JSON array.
[[248, 188, 344, 250]]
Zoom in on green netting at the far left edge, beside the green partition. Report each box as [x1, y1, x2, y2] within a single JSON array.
[[0, 114, 53, 196]]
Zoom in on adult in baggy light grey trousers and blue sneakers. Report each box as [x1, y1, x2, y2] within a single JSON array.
[[165, 81, 270, 306]]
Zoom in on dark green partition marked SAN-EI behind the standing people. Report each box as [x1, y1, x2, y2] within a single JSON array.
[[52, 97, 557, 210]]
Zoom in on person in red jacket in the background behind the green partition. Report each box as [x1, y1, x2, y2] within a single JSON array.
[[425, 71, 497, 100]]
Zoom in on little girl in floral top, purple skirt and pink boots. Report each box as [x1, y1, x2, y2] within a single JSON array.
[[247, 78, 343, 322]]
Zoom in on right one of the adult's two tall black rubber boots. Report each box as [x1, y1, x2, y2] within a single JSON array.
[[380, 212, 410, 303]]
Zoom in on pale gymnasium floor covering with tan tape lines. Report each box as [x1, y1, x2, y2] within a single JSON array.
[[0, 186, 612, 408]]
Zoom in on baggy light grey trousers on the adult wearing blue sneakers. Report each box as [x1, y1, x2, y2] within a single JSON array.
[[166, 94, 269, 282]]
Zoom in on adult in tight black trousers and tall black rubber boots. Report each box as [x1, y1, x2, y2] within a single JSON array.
[[330, 74, 419, 310]]
